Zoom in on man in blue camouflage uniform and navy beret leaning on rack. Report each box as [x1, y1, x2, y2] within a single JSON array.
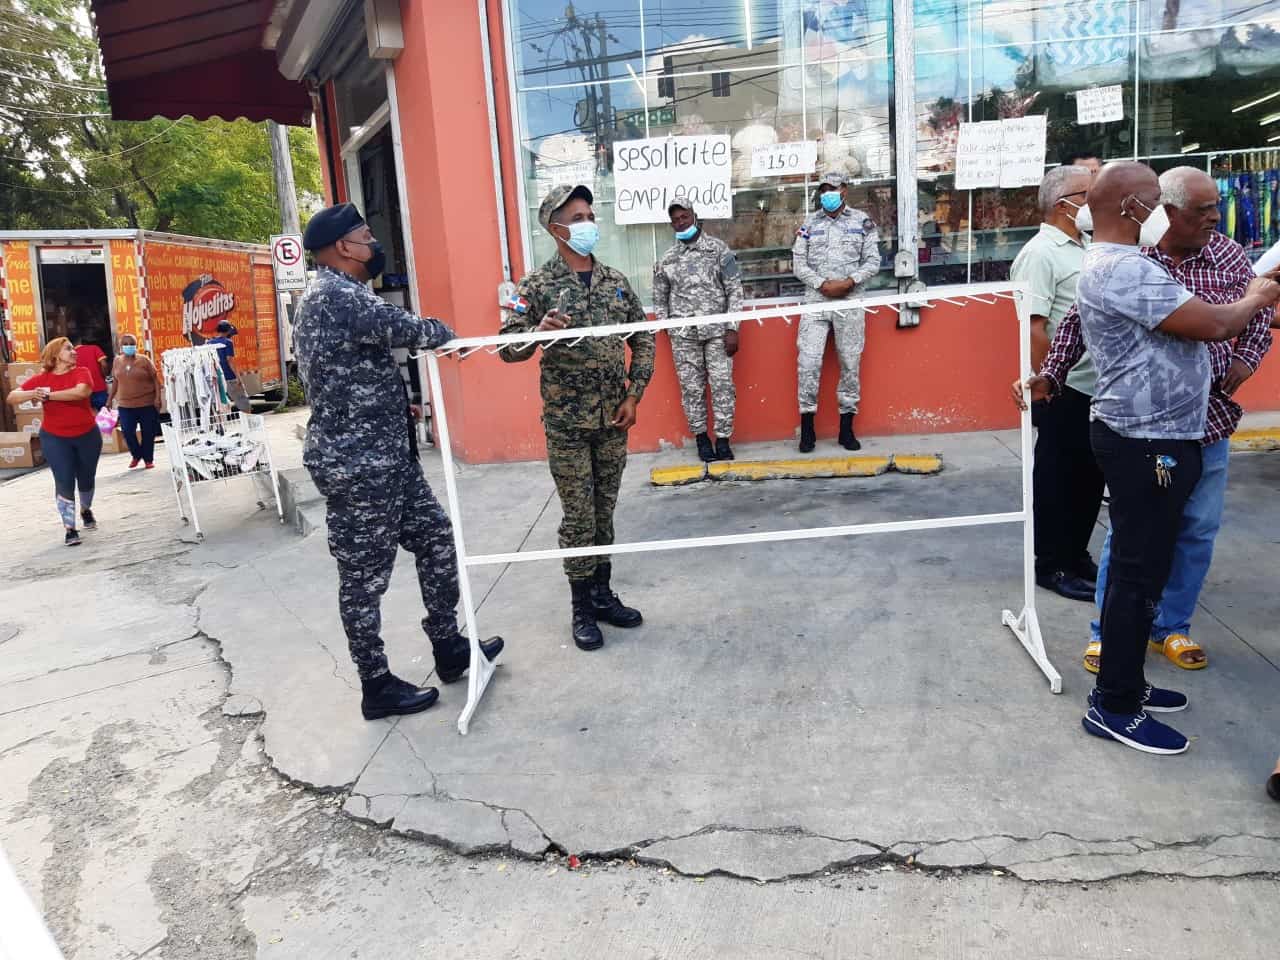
[[293, 204, 503, 719]]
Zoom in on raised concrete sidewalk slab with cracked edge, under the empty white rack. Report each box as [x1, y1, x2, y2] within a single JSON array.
[[201, 424, 1280, 879]]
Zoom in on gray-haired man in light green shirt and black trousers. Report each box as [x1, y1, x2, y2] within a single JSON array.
[[1009, 166, 1103, 602]]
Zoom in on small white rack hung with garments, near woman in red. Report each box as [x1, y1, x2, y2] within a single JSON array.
[[160, 347, 284, 541]]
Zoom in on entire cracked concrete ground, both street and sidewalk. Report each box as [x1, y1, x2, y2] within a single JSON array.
[[0, 415, 1280, 960]]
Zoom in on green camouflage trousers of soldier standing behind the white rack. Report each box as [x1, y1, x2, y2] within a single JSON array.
[[547, 426, 627, 580]]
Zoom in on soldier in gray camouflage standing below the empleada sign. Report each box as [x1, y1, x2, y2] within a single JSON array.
[[653, 201, 742, 461]]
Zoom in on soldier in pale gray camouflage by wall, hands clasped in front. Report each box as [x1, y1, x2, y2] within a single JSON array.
[[791, 172, 879, 453]]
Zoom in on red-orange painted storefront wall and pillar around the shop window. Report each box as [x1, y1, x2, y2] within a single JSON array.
[[325, 0, 1280, 462]]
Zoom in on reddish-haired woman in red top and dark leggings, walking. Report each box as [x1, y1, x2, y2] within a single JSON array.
[[9, 337, 102, 547]]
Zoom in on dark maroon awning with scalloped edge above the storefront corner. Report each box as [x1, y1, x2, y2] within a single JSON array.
[[92, 0, 311, 125]]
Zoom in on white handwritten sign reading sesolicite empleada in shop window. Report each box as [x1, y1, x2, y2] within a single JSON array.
[[613, 134, 733, 224]]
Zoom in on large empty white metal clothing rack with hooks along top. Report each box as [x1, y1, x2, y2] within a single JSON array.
[[426, 282, 1062, 733]]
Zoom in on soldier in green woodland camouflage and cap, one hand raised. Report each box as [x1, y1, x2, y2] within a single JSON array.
[[500, 186, 654, 650]]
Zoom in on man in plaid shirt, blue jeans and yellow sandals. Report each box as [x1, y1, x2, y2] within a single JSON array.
[[1028, 166, 1275, 673]]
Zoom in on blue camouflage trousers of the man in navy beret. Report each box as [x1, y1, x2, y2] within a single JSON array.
[[316, 462, 458, 680]]
